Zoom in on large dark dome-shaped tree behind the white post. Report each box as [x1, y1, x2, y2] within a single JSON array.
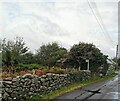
[[64, 42, 107, 72]]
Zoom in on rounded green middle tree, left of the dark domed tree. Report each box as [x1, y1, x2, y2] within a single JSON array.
[[37, 43, 67, 66]]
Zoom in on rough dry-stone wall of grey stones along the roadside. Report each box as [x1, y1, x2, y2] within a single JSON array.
[[2, 71, 90, 101]]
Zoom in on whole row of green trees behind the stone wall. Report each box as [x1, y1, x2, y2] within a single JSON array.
[[0, 37, 108, 75]]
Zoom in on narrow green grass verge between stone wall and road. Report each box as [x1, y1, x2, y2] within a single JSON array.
[[29, 73, 117, 101]]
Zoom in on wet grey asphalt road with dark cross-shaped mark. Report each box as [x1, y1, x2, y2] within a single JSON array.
[[55, 72, 120, 100]]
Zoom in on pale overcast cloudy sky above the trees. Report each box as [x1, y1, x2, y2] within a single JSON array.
[[0, 0, 118, 57]]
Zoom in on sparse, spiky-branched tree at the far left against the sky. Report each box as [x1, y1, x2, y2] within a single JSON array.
[[2, 37, 28, 67]]
